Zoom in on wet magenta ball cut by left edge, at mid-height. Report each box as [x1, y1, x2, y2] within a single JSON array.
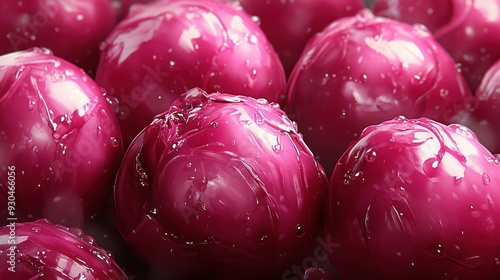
[[0, 49, 123, 227]]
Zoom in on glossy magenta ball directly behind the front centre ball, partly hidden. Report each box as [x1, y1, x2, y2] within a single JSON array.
[[96, 0, 286, 146]]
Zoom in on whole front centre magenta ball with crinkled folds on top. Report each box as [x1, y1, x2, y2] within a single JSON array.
[[115, 88, 328, 279]]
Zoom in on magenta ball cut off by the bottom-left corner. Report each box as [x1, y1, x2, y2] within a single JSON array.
[[0, 219, 128, 280]]
